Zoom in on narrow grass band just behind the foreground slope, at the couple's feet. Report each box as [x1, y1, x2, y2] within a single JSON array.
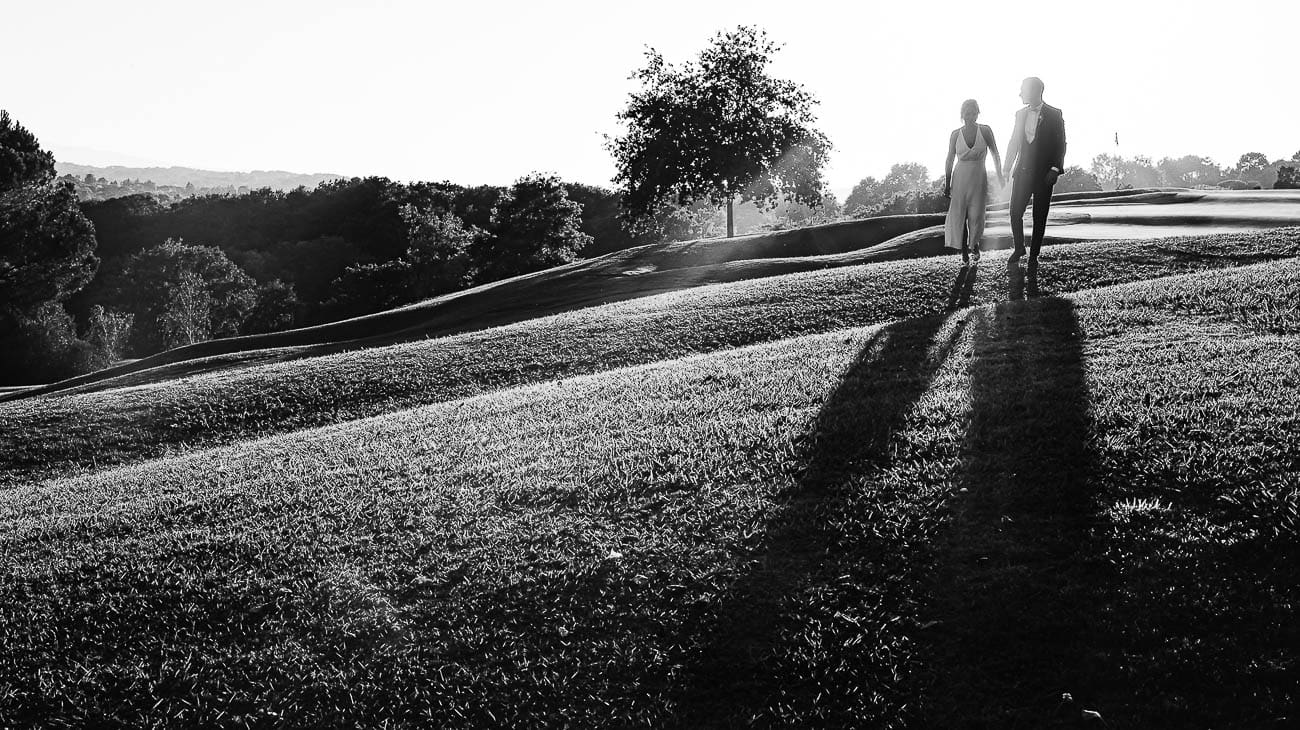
[[0, 229, 1300, 486]]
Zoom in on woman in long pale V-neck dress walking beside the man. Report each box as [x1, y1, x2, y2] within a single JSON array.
[[944, 99, 1006, 266]]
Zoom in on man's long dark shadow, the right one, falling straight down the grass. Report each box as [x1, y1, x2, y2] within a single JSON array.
[[920, 299, 1101, 729]]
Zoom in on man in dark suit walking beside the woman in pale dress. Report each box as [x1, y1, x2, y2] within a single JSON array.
[[1005, 77, 1065, 268]]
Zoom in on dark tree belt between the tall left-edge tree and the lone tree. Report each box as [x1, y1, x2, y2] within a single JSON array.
[[61, 175, 638, 366]]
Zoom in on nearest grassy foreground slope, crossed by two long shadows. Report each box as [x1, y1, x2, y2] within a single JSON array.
[[0, 260, 1300, 727]]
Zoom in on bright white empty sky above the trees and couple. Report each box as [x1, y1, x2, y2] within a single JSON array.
[[0, 0, 1300, 199]]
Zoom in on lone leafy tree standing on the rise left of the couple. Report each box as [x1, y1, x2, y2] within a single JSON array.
[[608, 26, 831, 236]]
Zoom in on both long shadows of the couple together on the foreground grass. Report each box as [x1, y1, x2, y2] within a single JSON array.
[[672, 292, 1092, 727]]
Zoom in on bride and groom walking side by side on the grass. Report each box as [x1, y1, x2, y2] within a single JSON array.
[[944, 77, 1065, 271]]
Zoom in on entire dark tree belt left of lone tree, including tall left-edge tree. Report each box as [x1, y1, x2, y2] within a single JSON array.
[[0, 114, 644, 384]]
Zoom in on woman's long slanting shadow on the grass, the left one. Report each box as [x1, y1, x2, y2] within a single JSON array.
[[671, 305, 967, 727]]
